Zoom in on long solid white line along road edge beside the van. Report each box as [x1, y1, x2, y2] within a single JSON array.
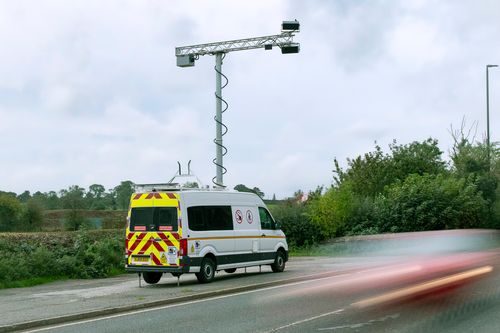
[[24, 273, 352, 333]]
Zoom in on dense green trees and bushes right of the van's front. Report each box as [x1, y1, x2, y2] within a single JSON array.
[[272, 131, 500, 246]]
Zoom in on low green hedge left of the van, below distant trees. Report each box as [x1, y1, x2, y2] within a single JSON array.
[[0, 230, 124, 287]]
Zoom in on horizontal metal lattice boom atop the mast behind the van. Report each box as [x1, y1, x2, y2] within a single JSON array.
[[175, 32, 294, 56]]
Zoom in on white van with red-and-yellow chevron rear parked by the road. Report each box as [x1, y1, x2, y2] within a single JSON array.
[[125, 189, 288, 284]]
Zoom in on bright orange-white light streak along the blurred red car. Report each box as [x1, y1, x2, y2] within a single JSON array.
[[352, 266, 493, 308]]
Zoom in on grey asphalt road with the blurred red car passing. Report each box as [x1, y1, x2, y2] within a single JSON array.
[[23, 254, 500, 333]]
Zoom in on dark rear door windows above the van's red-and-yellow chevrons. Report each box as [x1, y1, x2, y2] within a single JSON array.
[[130, 207, 177, 231]]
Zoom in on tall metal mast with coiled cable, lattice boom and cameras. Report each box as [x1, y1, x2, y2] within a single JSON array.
[[175, 20, 300, 188]]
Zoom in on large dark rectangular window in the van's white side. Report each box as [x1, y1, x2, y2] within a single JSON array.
[[188, 206, 233, 231]]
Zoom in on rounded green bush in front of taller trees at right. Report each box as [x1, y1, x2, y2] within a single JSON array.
[[375, 174, 487, 232]]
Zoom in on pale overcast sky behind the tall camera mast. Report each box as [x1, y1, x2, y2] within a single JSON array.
[[0, 0, 500, 198]]
